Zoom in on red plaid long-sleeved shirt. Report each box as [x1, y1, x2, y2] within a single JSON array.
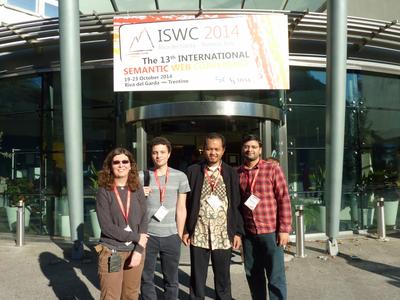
[[238, 160, 292, 234]]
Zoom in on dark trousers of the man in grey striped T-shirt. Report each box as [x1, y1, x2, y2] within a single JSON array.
[[140, 234, 181, 300]]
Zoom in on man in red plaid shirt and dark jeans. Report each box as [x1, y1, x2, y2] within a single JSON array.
[[238, 135, 292, 300]]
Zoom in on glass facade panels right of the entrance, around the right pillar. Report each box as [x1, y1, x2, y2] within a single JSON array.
[[287, 68, 400, 233]]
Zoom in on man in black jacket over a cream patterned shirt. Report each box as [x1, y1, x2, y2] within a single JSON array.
[[183, 133, 243, 300]]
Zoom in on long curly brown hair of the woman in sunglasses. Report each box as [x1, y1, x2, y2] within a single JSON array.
[[98, 147, 140, 192]]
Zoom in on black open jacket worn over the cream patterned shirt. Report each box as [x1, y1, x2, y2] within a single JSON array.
[[186, 161, 244, 241]]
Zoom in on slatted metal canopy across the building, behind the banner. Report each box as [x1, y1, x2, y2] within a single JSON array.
[[0, 8, 400, 77]]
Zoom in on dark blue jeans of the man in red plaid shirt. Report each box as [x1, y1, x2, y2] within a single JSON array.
[[243, 232, 287, 300]]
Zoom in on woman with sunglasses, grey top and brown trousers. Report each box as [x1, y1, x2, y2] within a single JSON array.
[[96, 148, 148, 299]]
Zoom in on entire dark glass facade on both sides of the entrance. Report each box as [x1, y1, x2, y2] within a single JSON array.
[[0, 67, 400, 238]]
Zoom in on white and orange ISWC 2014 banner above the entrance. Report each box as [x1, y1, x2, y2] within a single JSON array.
[[114, 14, 289, 91]]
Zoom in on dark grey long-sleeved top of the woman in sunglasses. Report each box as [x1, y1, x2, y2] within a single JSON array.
[[96, 186, 148, 253]]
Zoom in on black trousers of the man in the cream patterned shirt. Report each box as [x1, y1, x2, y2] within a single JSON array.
[[190, 246, 232, 300]]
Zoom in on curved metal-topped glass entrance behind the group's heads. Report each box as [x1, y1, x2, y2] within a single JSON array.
[[127, 101, 287, 171]]
